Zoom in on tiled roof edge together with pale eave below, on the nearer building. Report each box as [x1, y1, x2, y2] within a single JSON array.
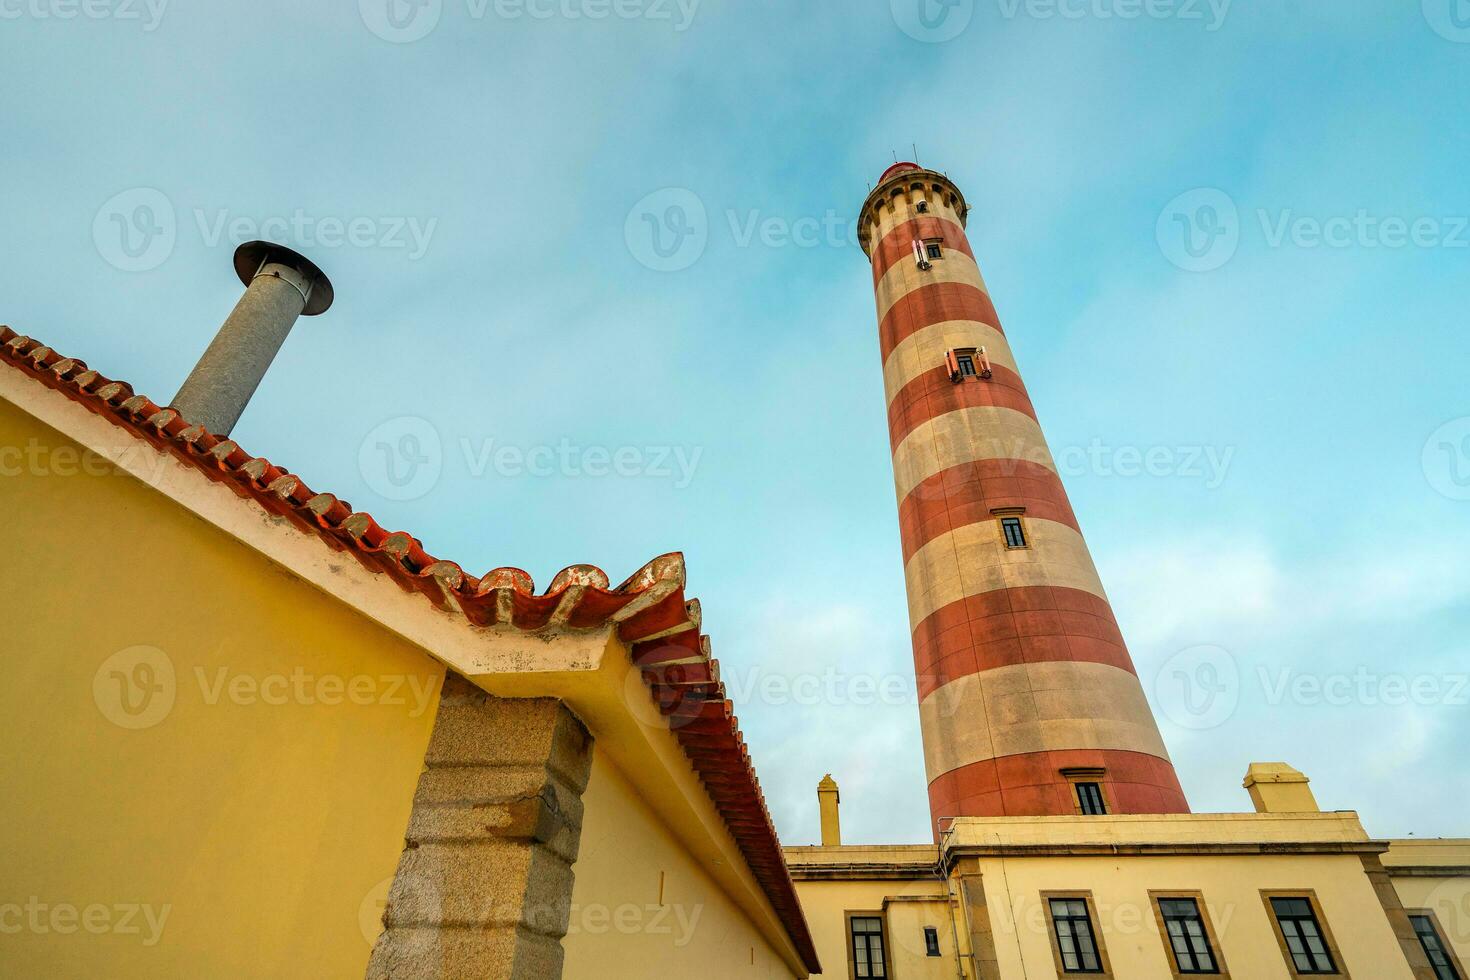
[[0, 326, 820, 974]]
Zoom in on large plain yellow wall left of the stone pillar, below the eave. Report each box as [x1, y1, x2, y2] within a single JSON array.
[[0, 401, 442, 977]]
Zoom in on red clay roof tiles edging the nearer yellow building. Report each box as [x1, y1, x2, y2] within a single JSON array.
[[0, 326, 820, 973]]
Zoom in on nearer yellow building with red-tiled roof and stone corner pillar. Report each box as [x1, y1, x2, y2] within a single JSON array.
[[0, 320, 819, 979]]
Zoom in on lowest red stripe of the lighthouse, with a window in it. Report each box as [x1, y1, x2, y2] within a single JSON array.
[[929, 749, 1189, 820]]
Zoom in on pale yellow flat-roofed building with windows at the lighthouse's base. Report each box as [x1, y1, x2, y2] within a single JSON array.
[[786, 764, 1470, 980]]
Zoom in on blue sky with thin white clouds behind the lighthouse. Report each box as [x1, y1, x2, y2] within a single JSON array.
[[0, 0, 1470, 843]]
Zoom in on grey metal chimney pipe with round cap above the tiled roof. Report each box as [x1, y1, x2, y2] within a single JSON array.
[[172, 241, 332, 435]]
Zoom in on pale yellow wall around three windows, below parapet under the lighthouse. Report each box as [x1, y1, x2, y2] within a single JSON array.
[[980, 855, 1411, 980]]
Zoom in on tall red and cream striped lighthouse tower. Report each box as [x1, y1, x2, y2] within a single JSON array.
[[858, 163, 1189, 833]]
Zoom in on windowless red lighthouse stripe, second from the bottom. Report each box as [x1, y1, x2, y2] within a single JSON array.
[[913, 585, 1138, 701]]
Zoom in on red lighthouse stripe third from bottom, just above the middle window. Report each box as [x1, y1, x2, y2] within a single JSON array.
[[898, 458, 1082, 563]]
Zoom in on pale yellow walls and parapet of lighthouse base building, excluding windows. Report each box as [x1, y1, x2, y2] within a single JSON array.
[[786, 811, 1452, 980]]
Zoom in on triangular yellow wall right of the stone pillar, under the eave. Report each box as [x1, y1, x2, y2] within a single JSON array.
[[562, 749, 792, 980]]
